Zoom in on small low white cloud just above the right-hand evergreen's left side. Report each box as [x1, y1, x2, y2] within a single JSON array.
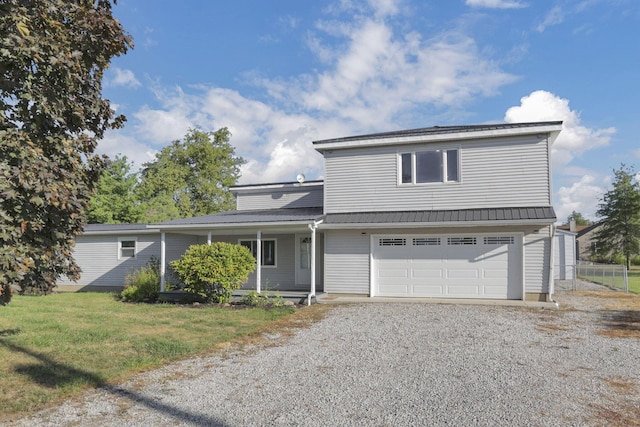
[[554, 174, 605, 222]]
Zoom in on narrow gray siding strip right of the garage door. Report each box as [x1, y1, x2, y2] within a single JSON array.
[[524, 227, 551, 293]]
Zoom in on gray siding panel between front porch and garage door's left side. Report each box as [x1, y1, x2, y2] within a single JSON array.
[[324, 230, 370, 295]]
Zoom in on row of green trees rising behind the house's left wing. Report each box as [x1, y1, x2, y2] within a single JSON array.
[[87, 128, 244, 224]]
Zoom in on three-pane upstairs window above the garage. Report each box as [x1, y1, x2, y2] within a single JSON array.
[[399, 149, 460, 184]]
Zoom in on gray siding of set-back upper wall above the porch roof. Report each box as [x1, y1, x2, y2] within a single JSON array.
[[236, 186, 323, 210]]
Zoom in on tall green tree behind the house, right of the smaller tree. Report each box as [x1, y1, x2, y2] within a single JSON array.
[[137, 128, 244, 222]]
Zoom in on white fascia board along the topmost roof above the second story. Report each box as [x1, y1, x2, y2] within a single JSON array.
[[314, 125, 562, 152]]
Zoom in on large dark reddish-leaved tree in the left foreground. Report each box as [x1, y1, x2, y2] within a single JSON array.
[[0, 0, 132, 293]]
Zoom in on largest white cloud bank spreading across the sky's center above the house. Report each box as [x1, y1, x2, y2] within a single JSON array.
[[107, 0, 516, 183]]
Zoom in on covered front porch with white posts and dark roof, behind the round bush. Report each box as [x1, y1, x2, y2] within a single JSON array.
[[155, 209, 324, 301]]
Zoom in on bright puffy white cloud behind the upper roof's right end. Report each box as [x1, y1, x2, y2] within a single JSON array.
[[504, 90, 616, 173]]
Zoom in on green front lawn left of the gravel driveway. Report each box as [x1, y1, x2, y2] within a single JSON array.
[[0, 293, 295, 417]]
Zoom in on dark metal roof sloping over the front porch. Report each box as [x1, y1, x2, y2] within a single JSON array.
[[149, 207, 323, 229]]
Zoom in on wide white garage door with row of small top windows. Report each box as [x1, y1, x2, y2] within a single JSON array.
[[373, 235, 522, 299]]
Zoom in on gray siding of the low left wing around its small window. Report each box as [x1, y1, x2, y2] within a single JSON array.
[[58, 234, 160, 286]]
